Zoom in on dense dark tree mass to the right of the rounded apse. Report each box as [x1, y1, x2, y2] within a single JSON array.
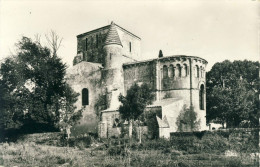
[[206, 60, 259, 127]]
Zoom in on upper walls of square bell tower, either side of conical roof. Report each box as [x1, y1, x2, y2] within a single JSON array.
[[74, 25, 141, 65]]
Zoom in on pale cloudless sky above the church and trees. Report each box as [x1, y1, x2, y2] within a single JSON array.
[[0, 0, 260, 71]]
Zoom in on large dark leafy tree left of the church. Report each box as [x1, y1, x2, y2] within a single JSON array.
[[0, 37, 81, 132]]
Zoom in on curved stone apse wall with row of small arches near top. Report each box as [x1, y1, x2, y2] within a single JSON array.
[[157, 55, 207, 130]]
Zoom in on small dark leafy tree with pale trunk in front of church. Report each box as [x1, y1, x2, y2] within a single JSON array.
[[119, 83, 154, 138]]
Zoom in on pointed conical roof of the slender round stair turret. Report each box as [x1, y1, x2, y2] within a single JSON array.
[[104, 22, 123, 46]]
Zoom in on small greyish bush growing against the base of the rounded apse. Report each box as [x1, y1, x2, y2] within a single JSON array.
[[176, 105, 200, 132]]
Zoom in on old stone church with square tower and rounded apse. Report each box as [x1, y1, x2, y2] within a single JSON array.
[[66, 22, 207, 138]]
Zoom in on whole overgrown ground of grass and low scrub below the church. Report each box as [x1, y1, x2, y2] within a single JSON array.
[[0, 130, 259, 167]]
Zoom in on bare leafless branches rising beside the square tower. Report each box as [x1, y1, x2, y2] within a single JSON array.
[[45, 30, 63, 56]]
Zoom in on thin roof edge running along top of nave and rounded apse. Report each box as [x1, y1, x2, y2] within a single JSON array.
[[123, 55, 208, 66]]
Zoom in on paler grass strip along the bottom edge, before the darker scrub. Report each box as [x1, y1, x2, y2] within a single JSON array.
[[0, 142, 257, 167]]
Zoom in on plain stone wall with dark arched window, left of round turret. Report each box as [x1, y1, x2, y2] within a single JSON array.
[[66, 62, 103, 135]]
